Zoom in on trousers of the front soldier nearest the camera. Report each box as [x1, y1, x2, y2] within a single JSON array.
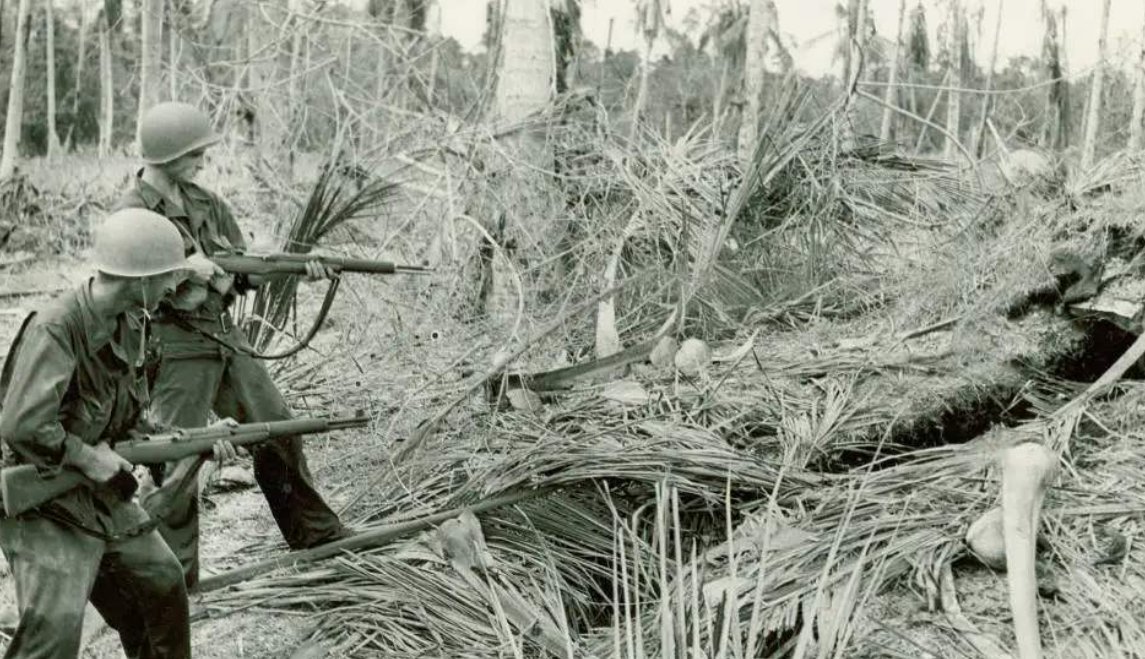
[[0, 516, 191, 659]]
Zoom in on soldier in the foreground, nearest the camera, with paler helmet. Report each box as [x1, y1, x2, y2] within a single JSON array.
[[0, 211, 194, 659]]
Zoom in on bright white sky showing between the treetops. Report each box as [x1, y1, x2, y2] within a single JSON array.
[[439, 0, 1145, 74]]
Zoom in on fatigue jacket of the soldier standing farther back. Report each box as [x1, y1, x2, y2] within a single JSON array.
[[115, 169, 251, 343]]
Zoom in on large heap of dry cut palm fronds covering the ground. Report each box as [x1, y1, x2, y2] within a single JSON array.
[[196, 82, 1145, 657]]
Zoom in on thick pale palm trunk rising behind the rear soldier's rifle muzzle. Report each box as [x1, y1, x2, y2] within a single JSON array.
[[484, 0, 551, 328]]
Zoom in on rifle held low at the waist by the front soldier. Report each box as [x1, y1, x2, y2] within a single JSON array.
[[0, 414, 370, 517]]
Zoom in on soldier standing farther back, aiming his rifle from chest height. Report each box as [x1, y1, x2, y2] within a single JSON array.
[[118, 103, 348, 588]]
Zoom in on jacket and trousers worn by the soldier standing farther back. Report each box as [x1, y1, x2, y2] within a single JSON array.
[[117, 175, 346, 587]]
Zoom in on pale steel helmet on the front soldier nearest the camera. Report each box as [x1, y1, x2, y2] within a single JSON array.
[[94, 208, 190, 277]]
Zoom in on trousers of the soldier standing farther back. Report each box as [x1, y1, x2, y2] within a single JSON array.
[[143, 324, 346, 588]]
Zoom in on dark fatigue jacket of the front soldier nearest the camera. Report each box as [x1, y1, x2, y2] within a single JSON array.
[[0, 279, 155, 535]]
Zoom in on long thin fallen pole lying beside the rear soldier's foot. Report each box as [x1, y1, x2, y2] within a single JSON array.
[[194, 487, 556, 594]]
